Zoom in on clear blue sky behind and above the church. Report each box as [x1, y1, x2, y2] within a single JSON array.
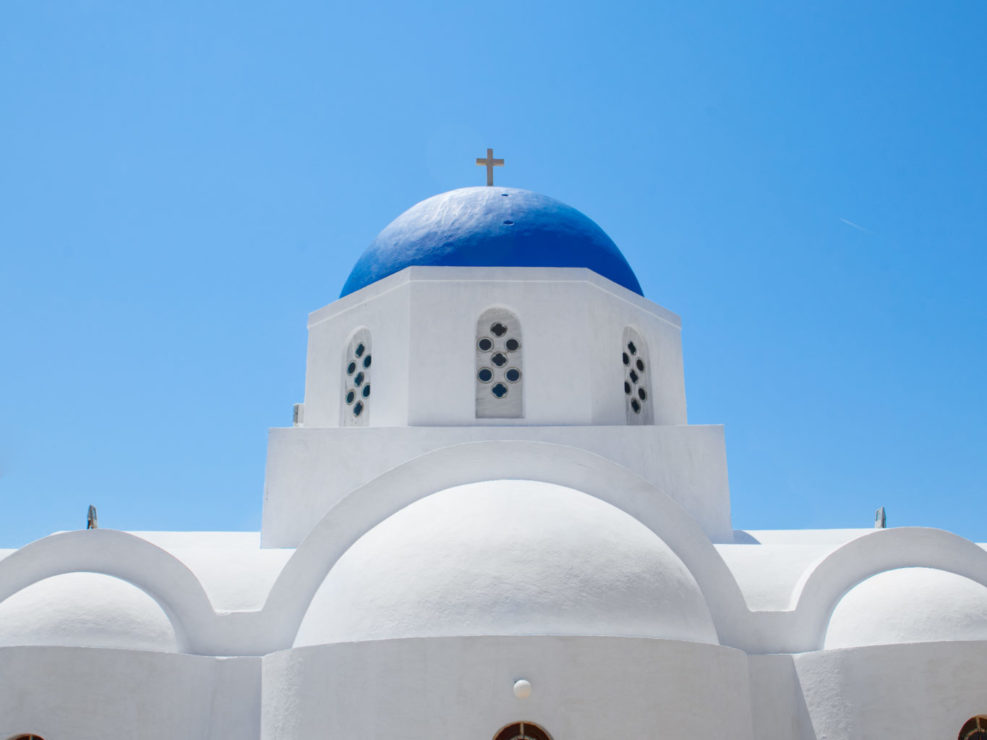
[[0, 0, 987, 546]]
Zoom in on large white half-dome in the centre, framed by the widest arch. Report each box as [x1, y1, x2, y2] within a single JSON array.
[[295, 480, 718, 647]]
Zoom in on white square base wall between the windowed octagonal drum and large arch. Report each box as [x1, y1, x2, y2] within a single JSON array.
[[263, 422, 733, 547]]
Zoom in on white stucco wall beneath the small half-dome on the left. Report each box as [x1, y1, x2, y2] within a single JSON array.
[[0, 647, 260, 740]]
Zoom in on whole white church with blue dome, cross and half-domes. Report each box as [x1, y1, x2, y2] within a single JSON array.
[[0, 168, 987, 740]]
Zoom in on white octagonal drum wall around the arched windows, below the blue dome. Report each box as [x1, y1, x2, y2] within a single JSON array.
[[304, 267, 686, 427]]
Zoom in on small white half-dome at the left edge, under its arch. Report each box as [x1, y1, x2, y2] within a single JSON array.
[[0, 573, 178, 652]]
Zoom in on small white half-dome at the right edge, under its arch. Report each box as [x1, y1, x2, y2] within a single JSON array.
[[826, 568, 987, 650]]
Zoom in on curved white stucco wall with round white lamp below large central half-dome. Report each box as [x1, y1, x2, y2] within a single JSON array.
[[261, 637, 753, 740]]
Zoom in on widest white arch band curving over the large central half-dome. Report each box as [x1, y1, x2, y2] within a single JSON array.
[[264, 440, 751, 647]]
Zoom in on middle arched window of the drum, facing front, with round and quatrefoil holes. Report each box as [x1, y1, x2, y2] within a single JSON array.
[[475, 308, 524, 419]]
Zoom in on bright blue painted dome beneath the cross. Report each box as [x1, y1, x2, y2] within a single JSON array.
[[340, 187, 644, 298]]
